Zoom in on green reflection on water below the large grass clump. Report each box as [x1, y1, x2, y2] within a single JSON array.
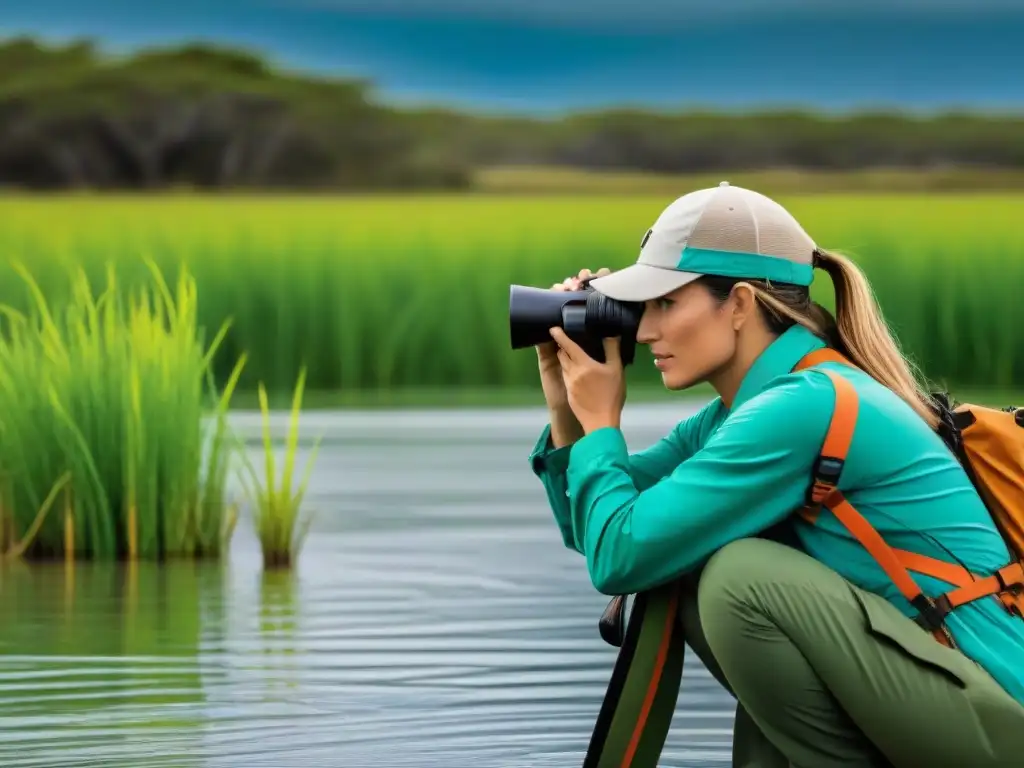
[[0, 563, 211, 767]]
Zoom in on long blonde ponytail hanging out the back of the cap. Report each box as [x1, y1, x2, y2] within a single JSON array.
[[817, 249, 939, 429]]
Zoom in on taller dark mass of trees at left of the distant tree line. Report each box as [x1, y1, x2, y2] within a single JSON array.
[[0, 39, 464, 189]]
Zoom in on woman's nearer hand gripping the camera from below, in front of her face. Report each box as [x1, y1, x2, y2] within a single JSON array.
[[551, 328, 626, 434]]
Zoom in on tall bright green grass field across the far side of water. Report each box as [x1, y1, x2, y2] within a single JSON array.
[[0, 186, 1024, 404]]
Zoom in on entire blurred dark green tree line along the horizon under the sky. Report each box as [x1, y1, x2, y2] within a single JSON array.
[[0, 37, 1024, 190]]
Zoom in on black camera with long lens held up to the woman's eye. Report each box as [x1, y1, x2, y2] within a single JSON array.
[[509, 280, 644, 366]]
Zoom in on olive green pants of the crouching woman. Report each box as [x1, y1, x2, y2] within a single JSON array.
[[680, 539, 1024, 768]]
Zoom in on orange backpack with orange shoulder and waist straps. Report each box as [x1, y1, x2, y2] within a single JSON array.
[[794, 348, 1024, 647]]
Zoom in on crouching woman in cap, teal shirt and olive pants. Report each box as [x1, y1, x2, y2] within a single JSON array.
[[530, 183, 1024, 768]]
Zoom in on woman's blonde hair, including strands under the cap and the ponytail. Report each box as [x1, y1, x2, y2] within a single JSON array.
[[713, 249, 940, 429]]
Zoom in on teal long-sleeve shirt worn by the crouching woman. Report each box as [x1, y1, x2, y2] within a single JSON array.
[[530, 326, 1024, 702]]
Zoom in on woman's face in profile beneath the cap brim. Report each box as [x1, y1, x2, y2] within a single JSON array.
[[637, 283, 736, 389]]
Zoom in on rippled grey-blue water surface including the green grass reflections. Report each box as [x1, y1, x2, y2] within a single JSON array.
[[0, 406, 733, 768]]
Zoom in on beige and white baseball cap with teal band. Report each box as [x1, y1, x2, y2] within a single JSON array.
[[590, 181, 816, 301]]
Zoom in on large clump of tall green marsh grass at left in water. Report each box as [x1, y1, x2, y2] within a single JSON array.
[[0, 263, 244, 560]]
